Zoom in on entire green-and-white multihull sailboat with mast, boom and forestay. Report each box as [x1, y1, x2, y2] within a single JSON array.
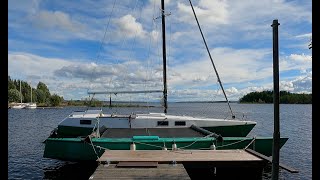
[[44, 0, 288, 161]]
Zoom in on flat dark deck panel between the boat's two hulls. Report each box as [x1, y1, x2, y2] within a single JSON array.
[[101, 128, 205, 138]]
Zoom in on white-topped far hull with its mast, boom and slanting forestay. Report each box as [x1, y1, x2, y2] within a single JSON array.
[[50, 0, 256, 137]]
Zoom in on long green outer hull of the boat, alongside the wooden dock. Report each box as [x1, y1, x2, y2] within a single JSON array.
[[44, 137, 288, 161]]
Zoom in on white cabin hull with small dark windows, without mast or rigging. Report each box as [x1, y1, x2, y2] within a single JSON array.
[[58, 111, 256, 136]]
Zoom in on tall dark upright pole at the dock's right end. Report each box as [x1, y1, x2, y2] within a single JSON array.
[[271, 19, 280, 180]]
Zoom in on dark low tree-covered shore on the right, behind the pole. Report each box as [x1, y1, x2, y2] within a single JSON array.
[[239, 91, 312, 104]]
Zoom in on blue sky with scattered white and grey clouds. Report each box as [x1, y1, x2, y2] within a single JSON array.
[[8, 0, 312, 102]]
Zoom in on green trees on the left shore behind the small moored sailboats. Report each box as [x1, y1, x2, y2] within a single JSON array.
[[8, 76, 63, 106]]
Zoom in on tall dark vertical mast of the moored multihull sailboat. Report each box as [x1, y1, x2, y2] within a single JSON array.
[[161, 0, 168, 113]]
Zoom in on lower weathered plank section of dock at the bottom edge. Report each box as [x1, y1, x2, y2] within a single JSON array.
[[89, 164, 191, 180]]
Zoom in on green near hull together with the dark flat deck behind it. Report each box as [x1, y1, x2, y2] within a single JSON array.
[[44, 125, 288, 161]]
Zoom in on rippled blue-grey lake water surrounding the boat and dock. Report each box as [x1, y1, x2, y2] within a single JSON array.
[[8, 103, 312, 180]]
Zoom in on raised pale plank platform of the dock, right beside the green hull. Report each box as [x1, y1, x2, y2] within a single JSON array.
[[97, 150, 263, 163]]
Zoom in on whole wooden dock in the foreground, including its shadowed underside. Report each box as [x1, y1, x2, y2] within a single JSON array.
[[90, 150, 266, 180]]
